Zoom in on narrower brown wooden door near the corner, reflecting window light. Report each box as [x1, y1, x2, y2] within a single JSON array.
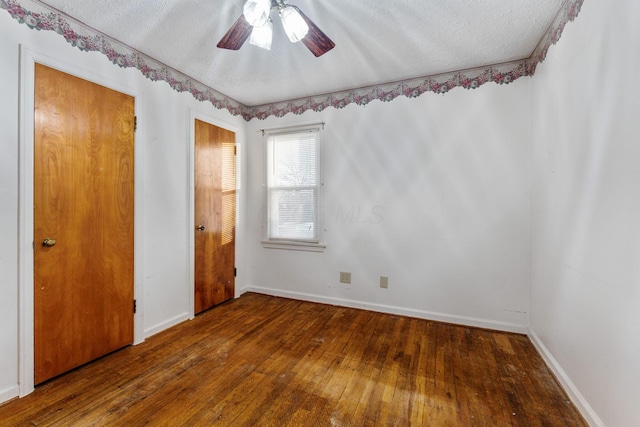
[[194, 120, 236, 313]]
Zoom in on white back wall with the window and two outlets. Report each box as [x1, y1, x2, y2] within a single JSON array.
[[242, 79, 531, 331]]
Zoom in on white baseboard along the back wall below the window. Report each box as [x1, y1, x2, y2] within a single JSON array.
[[240, 286, 528, 334]]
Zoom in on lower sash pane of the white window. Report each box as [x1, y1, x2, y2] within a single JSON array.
[[269, 188, 318, 241]]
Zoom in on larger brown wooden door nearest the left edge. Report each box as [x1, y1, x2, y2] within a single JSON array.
[[34, 64, 134, 384]]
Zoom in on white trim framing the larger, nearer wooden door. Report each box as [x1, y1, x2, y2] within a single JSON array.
[[18, 44, 144, 397]]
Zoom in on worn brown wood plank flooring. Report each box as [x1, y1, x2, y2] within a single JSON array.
[[0, 293, 587, 427]]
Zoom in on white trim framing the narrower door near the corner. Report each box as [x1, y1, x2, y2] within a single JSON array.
[[187, 112, 242, 319]]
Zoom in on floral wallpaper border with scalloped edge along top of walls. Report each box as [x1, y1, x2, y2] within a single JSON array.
[[0, 0, 584, 121]]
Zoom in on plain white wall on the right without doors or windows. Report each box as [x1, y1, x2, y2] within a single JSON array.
[[531, 0, 640, 426]]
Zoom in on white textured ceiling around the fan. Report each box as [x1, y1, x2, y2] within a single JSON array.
[[36, 0, 563, 106]]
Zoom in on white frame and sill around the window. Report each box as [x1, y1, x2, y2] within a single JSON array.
[[261, 123, 326, 252]]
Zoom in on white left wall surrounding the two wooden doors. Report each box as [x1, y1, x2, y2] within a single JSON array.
[[0, 9, 246, 402]]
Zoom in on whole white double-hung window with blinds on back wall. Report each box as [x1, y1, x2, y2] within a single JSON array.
[[263, 124, 324, 251]]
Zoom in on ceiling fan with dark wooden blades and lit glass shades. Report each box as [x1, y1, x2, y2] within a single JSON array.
[[218, 0, 335, 56]]
